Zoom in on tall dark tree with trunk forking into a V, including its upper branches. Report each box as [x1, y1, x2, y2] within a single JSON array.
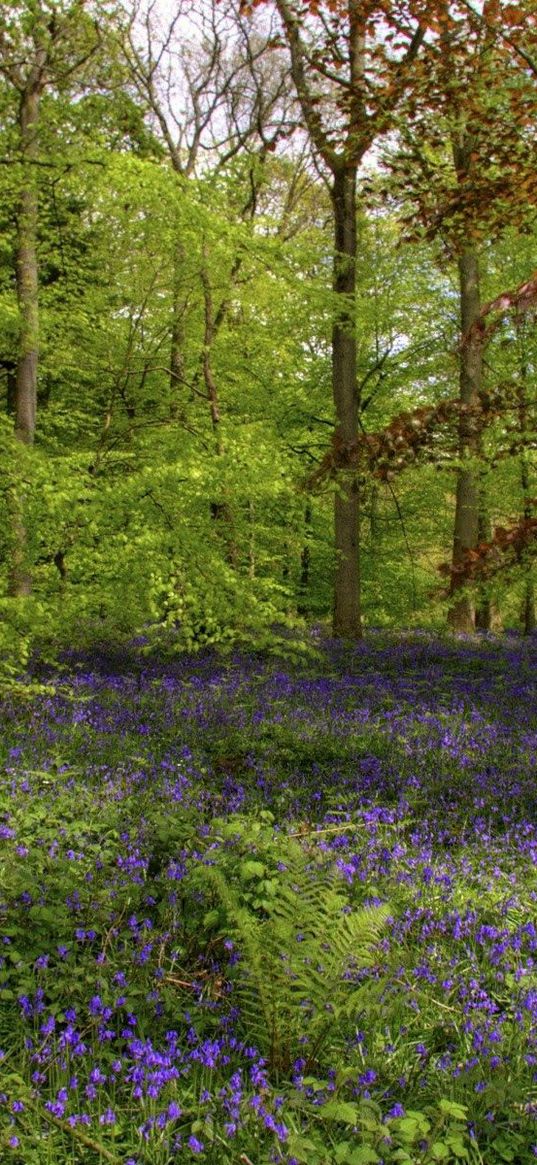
[[245, 0, 426, 637]]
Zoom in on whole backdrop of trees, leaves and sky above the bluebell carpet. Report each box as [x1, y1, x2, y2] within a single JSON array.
[[0, 0, 537, 676]]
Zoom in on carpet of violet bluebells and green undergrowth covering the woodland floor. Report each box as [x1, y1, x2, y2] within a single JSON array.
[[0, 634, 537, 1165]]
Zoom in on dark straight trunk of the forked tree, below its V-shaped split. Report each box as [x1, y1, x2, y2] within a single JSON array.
[[331, 165, 362, 638]]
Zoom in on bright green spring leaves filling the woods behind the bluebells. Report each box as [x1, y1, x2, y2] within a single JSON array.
[[0, 2, 535, 677]]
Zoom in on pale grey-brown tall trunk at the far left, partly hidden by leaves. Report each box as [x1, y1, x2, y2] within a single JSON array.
[[8, 79, 41, 598]]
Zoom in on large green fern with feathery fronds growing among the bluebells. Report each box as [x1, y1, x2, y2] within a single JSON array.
[[198, 843, 389, 1073]]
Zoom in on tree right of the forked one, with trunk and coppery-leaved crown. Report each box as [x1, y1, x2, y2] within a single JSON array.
[[382, 2, 535, 634]]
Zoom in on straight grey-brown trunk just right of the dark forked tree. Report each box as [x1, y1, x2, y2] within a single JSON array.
[[447, 247, 482, 634]]
